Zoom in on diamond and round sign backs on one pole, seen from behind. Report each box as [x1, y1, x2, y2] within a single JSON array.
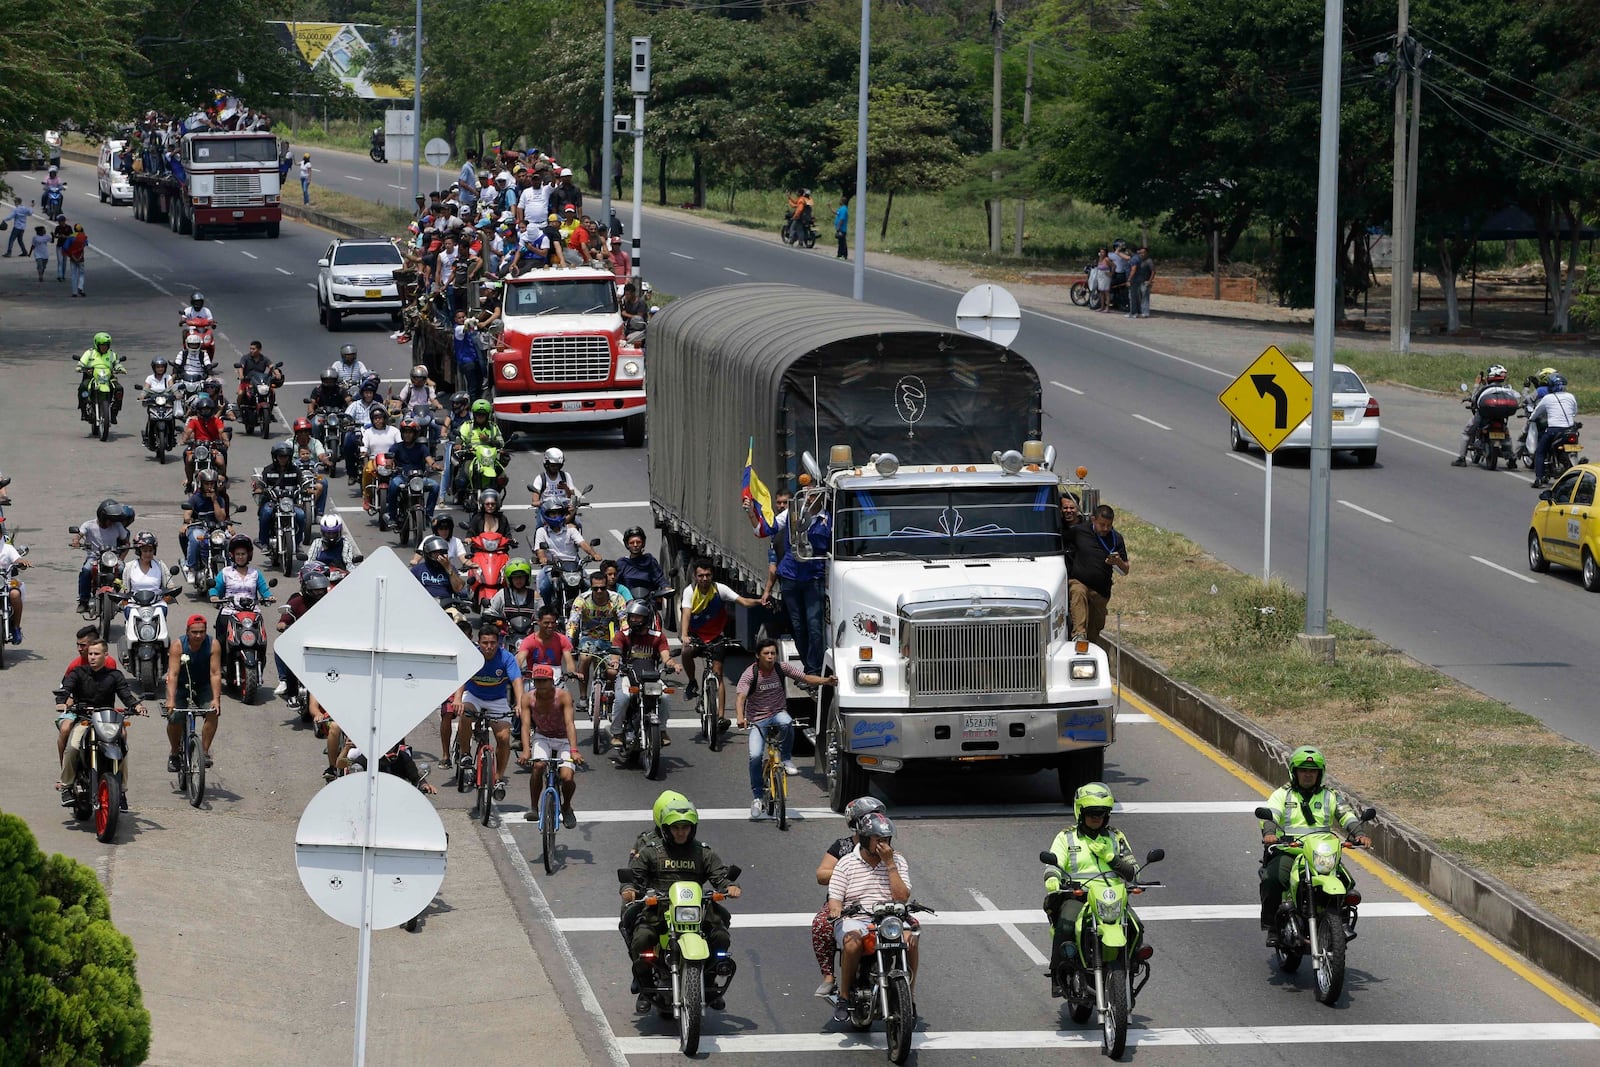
[[275, 547, 483, 1067]]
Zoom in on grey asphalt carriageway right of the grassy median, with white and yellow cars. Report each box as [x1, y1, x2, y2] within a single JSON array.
[[288, 141, 1600, 747]]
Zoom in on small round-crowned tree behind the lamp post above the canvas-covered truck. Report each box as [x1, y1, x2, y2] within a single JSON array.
[[821, 85, 960, 238]]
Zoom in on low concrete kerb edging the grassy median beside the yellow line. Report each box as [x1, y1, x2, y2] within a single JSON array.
[[1101, 635, 1600, 1001]]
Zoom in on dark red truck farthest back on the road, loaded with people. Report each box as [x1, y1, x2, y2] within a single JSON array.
[[130, 130, 283, 242]]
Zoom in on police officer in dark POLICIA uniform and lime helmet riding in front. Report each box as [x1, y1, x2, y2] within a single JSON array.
[[622, 790, 739, 1014]]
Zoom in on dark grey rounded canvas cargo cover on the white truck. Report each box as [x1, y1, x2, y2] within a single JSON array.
[[645, 285, 1042, 588]]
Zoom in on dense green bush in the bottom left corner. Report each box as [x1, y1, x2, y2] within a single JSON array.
[[0, 813, 150, 1067]]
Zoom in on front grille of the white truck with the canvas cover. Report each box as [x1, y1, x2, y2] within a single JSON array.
[[909, 619, 1045, 704]]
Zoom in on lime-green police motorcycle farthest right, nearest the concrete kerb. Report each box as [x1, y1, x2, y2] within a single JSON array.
[[1256, 806, 1378, 1006]]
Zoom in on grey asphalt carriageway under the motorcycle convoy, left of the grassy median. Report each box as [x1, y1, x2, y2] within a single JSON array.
[[0, 156, 1600, 1065]]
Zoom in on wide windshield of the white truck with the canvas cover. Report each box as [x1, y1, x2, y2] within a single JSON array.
[[834, 485, 1061, 560]]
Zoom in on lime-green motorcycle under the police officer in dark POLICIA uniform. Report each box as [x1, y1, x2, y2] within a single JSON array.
[[616, 864, 739, 1056]]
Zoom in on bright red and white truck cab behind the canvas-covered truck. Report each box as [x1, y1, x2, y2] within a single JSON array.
[[491, 267, 645, 448]]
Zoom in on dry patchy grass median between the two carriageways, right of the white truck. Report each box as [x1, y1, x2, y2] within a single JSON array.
[[1112, 512, 1600, 937]]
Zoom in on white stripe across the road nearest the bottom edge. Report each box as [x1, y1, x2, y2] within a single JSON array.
[[611, 1023, 1600, 1056]]
